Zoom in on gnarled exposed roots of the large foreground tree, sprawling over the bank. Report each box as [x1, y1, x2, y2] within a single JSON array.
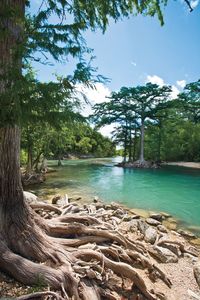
[[0, 199, 180, 300]]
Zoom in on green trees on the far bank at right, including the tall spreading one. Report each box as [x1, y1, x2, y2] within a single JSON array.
[[92, 81, 200, 164]]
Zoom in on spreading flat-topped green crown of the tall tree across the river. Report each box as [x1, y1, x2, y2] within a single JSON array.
[[92, 83, 173, 161]]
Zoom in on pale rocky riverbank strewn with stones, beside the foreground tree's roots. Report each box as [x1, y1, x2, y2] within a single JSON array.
[[0, 192, 200, 300]]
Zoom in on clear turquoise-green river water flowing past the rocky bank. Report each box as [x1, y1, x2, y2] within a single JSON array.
[[30, 159, 200, 231]]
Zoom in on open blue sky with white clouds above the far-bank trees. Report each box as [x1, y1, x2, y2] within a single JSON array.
[[30, 0, 200, 135]]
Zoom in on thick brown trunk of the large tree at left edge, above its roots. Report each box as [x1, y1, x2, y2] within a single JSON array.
[[0, 0, 28, 235]]
